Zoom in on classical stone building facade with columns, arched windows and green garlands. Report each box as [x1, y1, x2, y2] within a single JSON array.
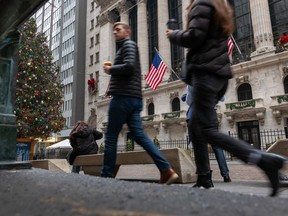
[[85, 0, 288, 149]]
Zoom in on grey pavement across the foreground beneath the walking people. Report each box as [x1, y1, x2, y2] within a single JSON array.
[[0, 161, 288, 216]]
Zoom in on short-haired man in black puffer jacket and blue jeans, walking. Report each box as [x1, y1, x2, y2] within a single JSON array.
[[101, 22, 178, 185]]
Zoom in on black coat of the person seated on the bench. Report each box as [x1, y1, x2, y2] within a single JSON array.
[[70, 128, 103, 155]]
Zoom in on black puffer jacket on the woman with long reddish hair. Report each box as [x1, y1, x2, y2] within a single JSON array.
[[169, 0, 232, 78]]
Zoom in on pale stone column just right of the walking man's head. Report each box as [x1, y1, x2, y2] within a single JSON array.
[[137, 0, 150, 79]]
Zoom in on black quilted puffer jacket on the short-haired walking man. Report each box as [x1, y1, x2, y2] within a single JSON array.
[[108, 39, 142, 99]]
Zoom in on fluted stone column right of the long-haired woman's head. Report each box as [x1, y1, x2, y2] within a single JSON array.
[[249, 0, 275, 60]]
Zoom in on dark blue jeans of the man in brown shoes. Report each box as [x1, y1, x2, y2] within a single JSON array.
[[101, 96, 171, 177]]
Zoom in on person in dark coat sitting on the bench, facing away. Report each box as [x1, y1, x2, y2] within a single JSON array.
[[69, 121, 103, 173]]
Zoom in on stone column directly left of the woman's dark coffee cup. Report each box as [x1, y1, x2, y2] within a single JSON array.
[[157, 0, 172, 81]]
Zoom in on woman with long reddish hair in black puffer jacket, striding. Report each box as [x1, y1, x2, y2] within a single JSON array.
[[166, 0, 286, 196]]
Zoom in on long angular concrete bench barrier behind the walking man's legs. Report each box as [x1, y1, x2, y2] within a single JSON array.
[[73, 148, 196, 183]]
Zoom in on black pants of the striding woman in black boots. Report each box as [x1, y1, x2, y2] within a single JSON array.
[[188, 74, 261, 175]]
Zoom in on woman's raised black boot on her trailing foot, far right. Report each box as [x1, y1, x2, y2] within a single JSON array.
[[258, 153, 285, 196]]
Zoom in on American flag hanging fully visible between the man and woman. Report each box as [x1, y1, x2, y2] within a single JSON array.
[[145, 52, 167, 90]]
